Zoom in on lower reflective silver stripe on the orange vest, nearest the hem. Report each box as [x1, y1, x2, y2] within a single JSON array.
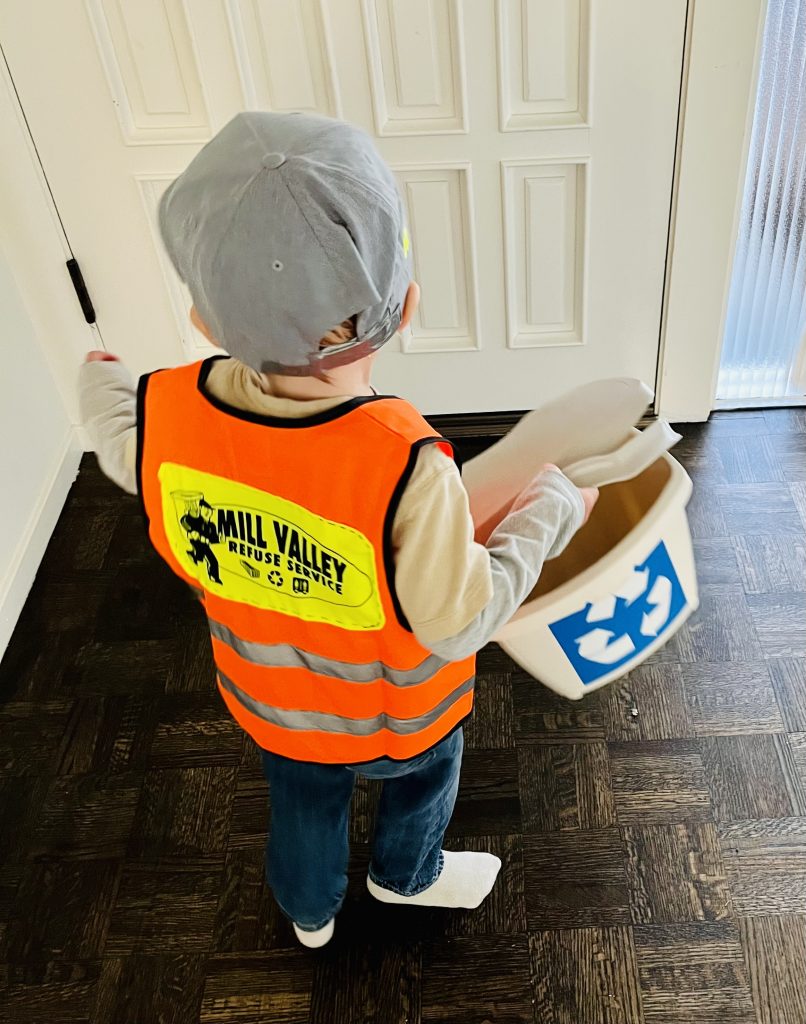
[[218, 672, 475, 736]]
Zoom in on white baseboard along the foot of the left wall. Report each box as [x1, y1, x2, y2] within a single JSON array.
[[0, 428, 83, 656]]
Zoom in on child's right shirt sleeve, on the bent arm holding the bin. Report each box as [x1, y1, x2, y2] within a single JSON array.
[[392, 446, 585, 660]]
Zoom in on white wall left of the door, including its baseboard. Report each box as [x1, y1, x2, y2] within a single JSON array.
[[0, 54, 89, 656]]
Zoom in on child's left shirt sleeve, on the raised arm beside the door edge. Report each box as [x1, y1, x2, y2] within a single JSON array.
[[79, 360, 137, 495]]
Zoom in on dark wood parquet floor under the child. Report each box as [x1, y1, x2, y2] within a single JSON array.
[[0, 411, 806, 1024]]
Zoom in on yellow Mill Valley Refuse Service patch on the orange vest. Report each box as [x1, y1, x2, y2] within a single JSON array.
[[159, 462, 386, 630]]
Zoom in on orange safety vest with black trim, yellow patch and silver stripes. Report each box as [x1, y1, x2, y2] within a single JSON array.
[[137, 356, 475, 764]]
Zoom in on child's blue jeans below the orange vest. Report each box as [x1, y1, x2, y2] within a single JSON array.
[[262, 728, 464, 931]]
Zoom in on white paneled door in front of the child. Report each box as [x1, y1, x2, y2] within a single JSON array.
[[0, 0, 687, 413]]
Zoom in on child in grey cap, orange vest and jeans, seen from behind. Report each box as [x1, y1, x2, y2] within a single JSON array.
[[81, 113, 596, 947]]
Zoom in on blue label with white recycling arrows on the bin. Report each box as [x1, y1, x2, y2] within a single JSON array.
[[549, 541, 686, 686]]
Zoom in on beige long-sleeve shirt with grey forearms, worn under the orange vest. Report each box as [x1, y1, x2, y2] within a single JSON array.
[[80, 359, 584, 659]]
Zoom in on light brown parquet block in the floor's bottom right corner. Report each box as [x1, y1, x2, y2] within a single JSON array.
[[738, 914, 806, 1024]]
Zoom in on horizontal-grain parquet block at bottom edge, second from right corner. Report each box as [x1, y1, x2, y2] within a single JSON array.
[[634, 921, 757, 1024]]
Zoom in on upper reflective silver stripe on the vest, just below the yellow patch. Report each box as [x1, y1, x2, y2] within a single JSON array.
[[210, 618, 451, 686]]
